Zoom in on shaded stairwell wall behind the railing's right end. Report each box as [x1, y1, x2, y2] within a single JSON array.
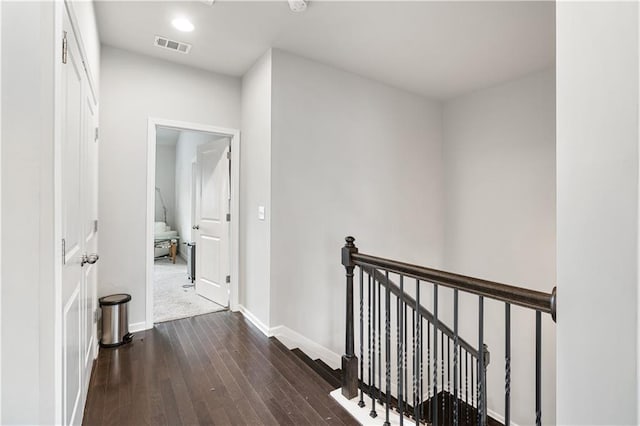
[[440, 69, 556, 425]]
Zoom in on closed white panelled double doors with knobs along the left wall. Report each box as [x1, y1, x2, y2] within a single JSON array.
[[59, 13, 97, 424]]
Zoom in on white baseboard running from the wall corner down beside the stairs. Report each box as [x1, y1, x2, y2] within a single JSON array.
[[237, 305, 342, 368]]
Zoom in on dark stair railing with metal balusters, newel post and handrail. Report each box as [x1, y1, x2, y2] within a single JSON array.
[[342, 237, 556, 426]]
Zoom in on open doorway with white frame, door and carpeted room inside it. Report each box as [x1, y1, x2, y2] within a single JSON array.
[[147, 119, 238, 328]]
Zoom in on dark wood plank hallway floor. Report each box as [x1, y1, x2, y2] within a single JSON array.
[[84, 312, 357, 425]]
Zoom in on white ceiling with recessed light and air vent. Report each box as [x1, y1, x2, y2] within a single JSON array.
[[96, 0, 555, 99]]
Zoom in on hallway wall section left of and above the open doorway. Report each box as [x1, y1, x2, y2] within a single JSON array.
[[98, 46, 240, 324]]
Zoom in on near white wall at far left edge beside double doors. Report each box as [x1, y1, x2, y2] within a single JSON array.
[[0, 2, 56, 424]]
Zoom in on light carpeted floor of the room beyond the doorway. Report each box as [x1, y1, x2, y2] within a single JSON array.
[[153, 256, 225, 322]]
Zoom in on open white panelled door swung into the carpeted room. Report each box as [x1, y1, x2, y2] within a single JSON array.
[[193, 140, 230, 306]]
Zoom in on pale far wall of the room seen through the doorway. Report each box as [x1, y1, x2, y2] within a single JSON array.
[[155, 144, 177, 229]]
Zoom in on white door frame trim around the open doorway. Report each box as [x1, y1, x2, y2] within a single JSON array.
[[145, 117, 240, 330]]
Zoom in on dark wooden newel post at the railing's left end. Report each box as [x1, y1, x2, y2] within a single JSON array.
[[342, 236, 358, 399]]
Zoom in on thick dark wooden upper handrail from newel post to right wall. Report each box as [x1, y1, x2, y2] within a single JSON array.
[[350, 251, 556, 321]]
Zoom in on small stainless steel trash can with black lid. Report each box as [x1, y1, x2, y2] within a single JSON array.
[[98, 294, 133, 348]]
